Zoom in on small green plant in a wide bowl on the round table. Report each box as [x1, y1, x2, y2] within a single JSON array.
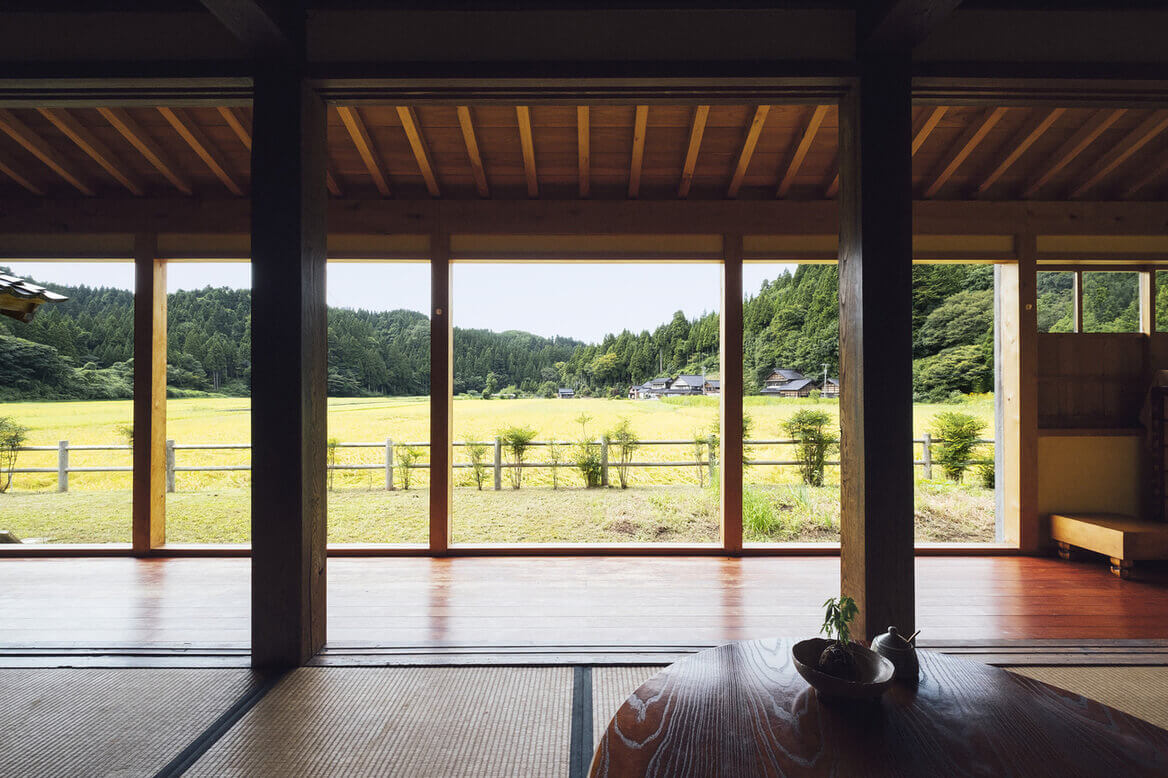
[[791, 596, 894, 700]]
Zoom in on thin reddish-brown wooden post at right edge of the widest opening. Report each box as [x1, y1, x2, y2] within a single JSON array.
[[718, 235, 743, 554]]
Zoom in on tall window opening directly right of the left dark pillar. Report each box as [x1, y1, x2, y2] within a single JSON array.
[[327, 262, 430, 544]]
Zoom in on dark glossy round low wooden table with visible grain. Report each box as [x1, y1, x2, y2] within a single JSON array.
[[591, 640, 1168, 778]]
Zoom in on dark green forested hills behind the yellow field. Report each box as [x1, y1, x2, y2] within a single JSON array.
[[0, 265, 993, 400]]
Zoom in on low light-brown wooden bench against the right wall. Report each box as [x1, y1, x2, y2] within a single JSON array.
[[1050, 513, 1168, 578]]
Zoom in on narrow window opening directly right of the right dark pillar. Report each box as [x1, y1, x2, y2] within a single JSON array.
[[912, 264, 995, 543]]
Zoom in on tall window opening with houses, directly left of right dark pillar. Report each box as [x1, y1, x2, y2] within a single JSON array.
[[743, 263, 840, 543]]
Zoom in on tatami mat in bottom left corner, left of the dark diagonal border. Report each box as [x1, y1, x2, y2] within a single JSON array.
[[0, 668, 253, 778]]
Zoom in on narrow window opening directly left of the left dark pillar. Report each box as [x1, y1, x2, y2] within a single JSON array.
[[166, 262, 251, 544]]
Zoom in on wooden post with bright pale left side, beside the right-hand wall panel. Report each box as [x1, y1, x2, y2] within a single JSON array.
[[997, 232, 1041, 554]]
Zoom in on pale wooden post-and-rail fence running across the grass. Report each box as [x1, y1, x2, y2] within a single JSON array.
[[12, 432, 994, 492]]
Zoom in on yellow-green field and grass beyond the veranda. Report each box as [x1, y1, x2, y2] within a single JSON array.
[[0, 397, 994, 543]]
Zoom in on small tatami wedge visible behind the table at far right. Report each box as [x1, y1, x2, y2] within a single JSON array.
[[1008, 667, 1168, 729]]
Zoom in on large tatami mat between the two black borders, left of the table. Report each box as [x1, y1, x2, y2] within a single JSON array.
[[186, 667, 572, 778]]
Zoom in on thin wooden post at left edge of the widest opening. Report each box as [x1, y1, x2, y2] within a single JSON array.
[[430, 234, 454, 554]]
